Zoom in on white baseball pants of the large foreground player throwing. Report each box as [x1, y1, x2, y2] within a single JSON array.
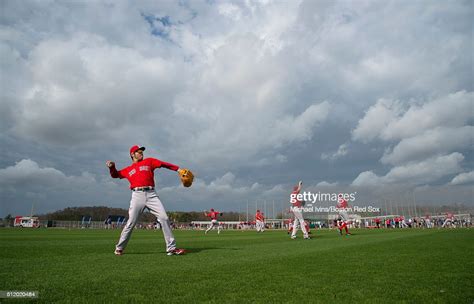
[[116, 190, 176, 252]]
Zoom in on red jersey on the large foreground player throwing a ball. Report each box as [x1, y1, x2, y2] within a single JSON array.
[[109, 158, 179, 189]]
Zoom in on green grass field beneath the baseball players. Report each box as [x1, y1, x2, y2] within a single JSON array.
[[0, 228, 474, 303]]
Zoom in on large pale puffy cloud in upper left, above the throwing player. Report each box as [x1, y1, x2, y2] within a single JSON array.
[[14, 34, 179, 145]]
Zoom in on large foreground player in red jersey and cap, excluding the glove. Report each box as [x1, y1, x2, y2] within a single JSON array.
[[106, 146, 185, 255]]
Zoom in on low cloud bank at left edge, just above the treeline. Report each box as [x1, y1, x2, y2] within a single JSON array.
[[0, 159, 115, 213]]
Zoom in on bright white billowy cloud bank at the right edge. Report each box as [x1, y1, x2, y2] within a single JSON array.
[[352, 91, 474, 184]]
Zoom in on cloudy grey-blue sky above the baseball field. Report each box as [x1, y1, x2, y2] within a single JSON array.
[[0, 0, 474, 217]]
